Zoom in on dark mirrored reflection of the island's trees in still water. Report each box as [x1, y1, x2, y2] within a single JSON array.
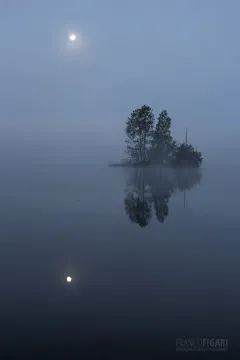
[[124, 168, 201, 227]]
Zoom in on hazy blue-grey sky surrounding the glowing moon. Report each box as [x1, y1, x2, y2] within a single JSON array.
[[0, 0, 240, 162]]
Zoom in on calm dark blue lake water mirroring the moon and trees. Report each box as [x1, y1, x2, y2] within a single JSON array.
[[0, 165, 240, 359]]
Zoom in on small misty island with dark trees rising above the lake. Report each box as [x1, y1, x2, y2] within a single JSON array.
[[109, 105, 203, 167]]
